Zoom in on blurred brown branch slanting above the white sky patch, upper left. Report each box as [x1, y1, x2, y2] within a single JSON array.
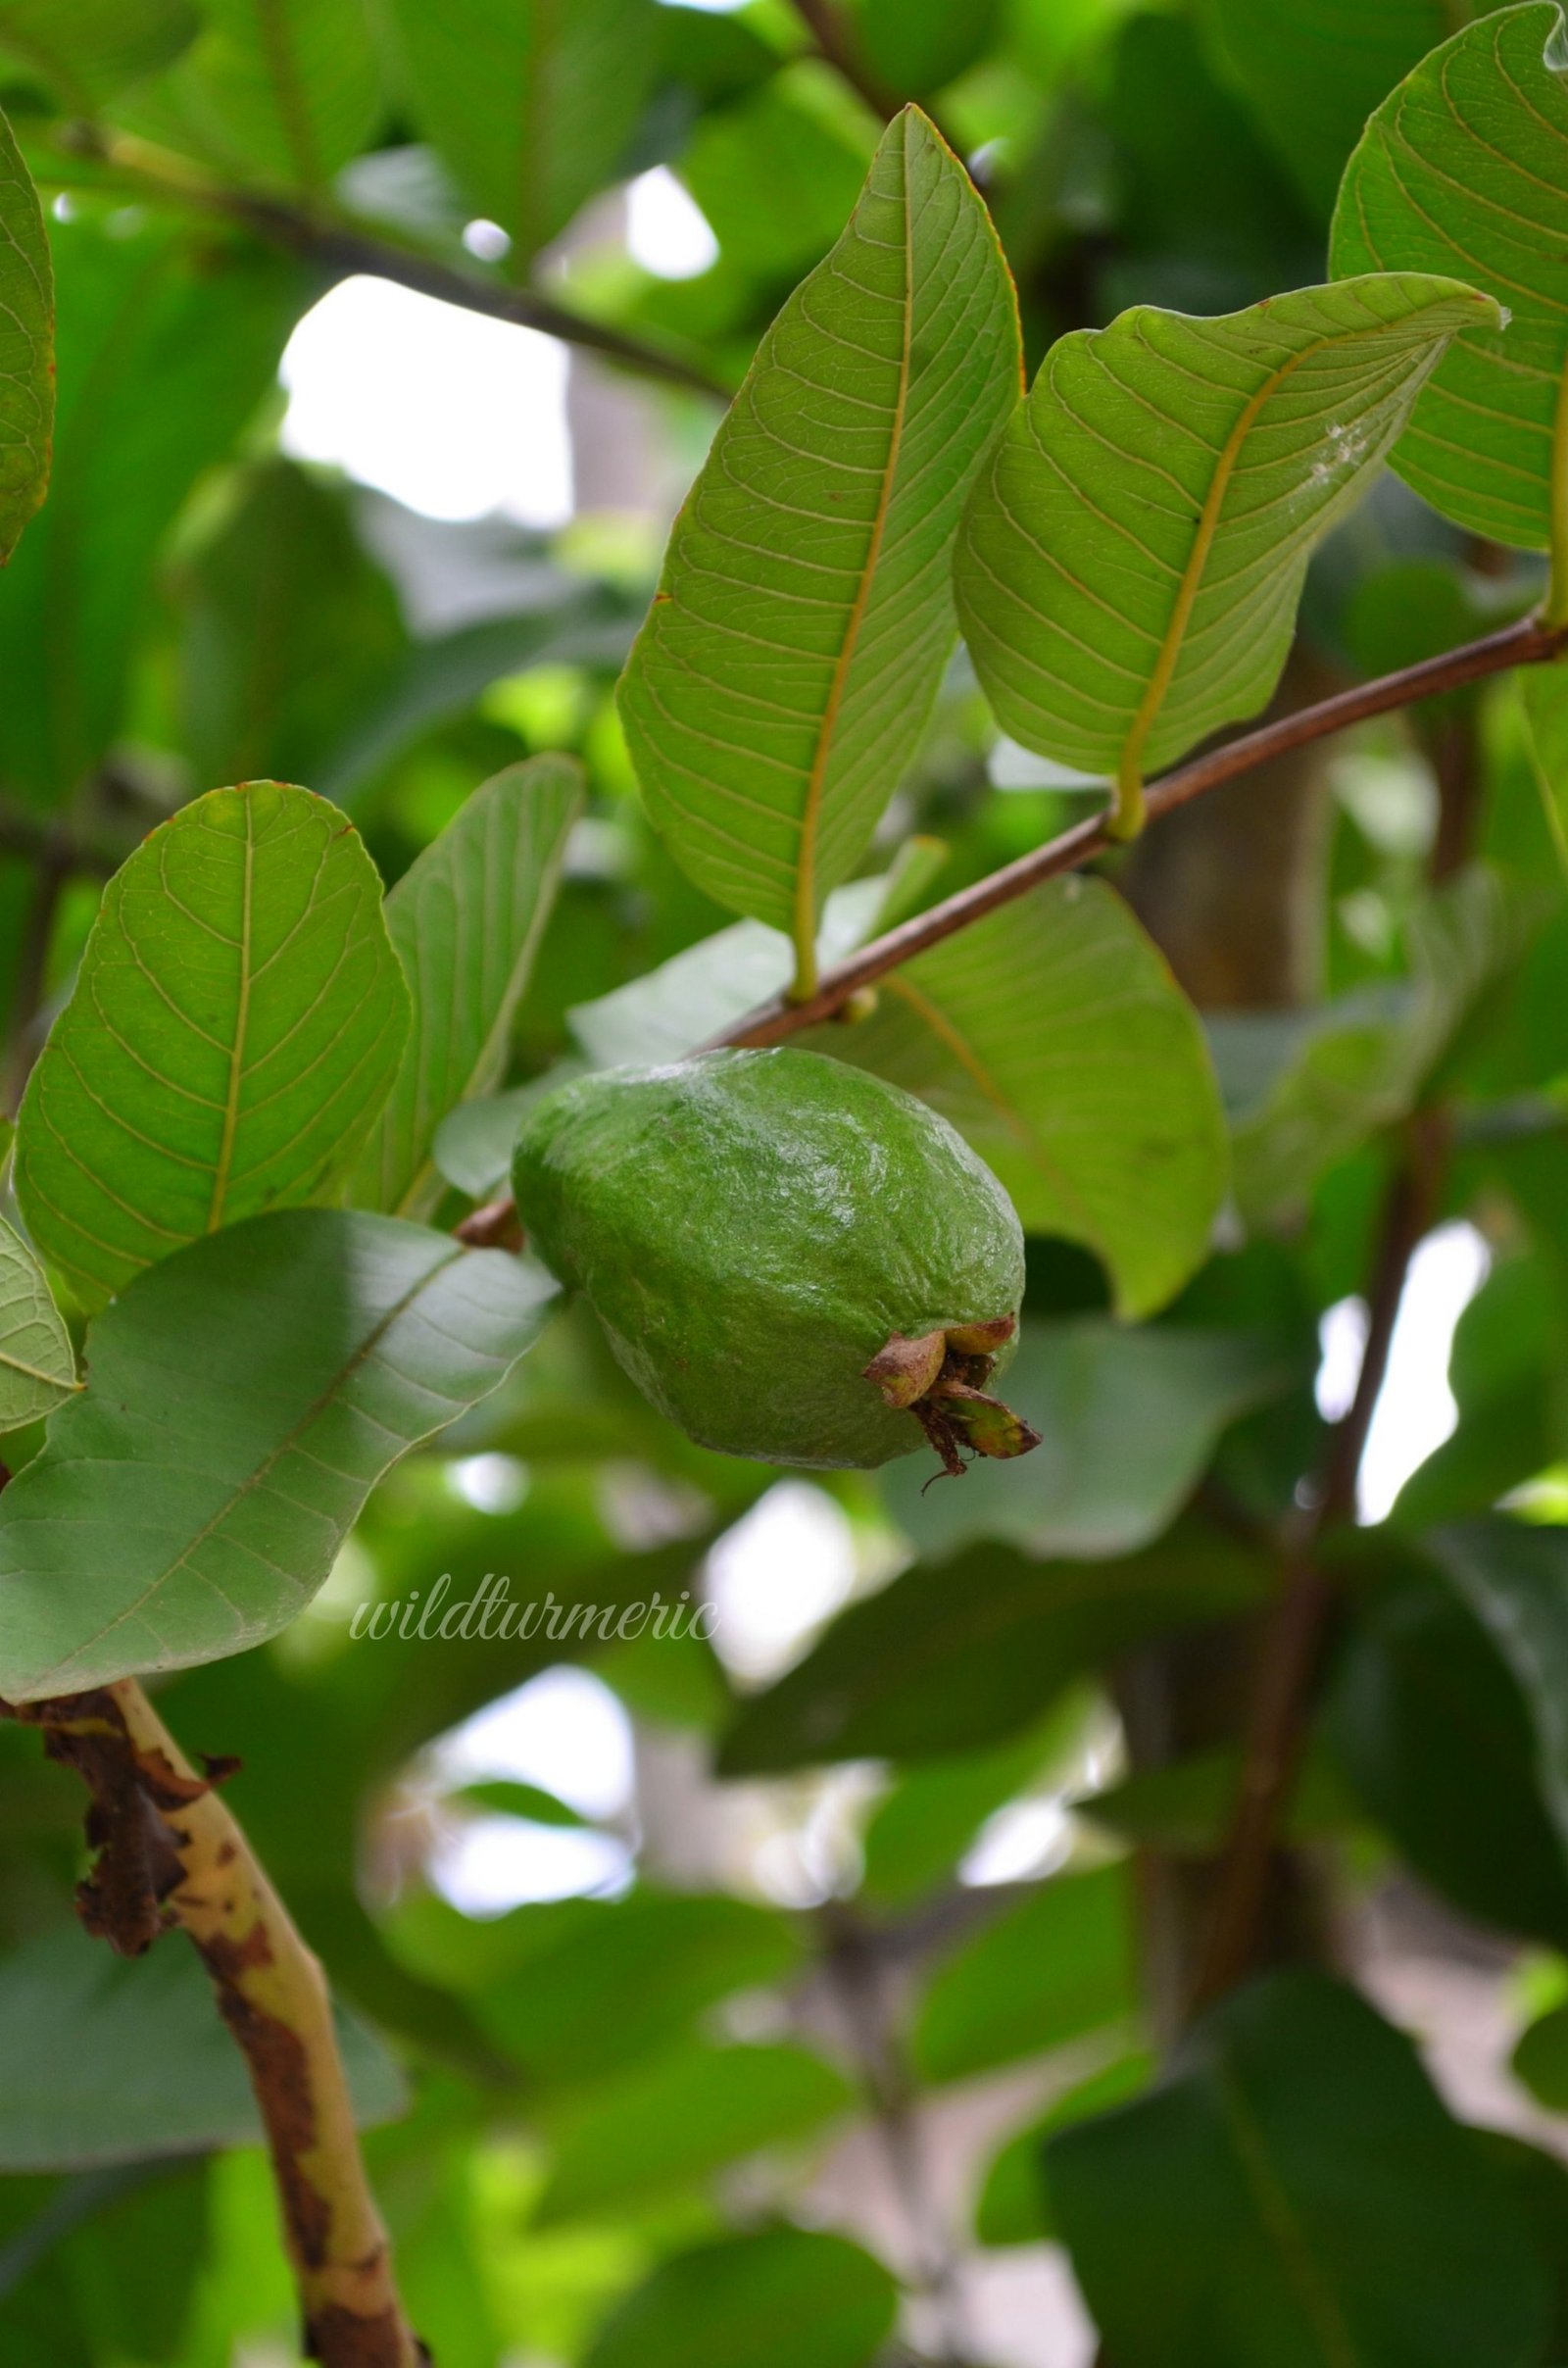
[[62, 123, 734, 403]]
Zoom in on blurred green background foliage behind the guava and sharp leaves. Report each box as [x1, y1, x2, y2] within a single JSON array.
[[0, 0, 1568, 2368]]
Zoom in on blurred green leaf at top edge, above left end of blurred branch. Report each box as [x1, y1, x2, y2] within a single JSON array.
[[121, 0, 381, 189]]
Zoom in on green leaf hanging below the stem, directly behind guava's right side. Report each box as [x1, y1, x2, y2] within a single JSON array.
[[803, 878, 1227, 1316]]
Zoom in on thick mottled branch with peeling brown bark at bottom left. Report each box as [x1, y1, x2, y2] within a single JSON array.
[[0, 1679, 426, 2368]]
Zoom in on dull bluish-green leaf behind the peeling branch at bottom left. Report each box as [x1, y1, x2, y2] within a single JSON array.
[[0, 1925, 408, 2171]]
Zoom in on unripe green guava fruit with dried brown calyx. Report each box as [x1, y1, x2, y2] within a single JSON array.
[[514, 1052, 1035, 1470]]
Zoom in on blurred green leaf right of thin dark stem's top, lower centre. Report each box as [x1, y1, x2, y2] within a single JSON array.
[[914, 1866, 1137, 2082]]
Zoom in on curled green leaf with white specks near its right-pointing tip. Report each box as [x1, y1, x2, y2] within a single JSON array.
[[956, 272, 1499, 805]]
